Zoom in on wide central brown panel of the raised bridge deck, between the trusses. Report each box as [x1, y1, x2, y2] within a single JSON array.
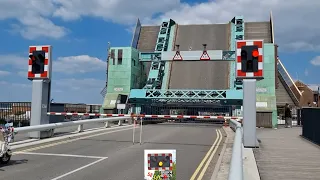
[[168, 24, 230, 89]]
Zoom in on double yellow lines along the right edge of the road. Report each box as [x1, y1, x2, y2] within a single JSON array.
[[190, 129, 222, 180]]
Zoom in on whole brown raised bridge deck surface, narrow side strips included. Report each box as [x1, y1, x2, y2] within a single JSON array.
[[138, 22, 271, 90]]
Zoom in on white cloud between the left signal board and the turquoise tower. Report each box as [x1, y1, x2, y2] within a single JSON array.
[[53, 55, 107, 74]]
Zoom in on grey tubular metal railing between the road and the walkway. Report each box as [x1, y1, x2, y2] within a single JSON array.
[[228, 120, 244, 180]]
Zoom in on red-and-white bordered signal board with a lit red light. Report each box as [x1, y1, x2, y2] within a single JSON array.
[[236, 40, 263, 79]]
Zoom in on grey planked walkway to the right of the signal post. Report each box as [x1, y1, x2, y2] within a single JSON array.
[[254, 127, 320, 180]]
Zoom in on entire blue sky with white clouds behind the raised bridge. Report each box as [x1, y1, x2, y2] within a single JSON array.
[[0, 0, 320, 104]]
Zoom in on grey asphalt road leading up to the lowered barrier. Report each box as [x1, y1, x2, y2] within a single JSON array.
[[0, 124, 225, 180]]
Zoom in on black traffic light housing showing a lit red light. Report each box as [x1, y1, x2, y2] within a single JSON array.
[[241, 45, 259, 72]]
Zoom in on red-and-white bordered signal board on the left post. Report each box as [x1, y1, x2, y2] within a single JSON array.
[[28, 45, 52, 80]]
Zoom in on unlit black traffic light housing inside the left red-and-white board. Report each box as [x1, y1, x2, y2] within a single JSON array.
[[29, 51, 45, 74]]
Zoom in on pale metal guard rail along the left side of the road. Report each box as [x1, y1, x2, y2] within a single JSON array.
[[14, 117, 131, 133]]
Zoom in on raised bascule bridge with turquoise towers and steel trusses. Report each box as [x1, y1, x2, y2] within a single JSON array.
[[103, 16, 298, 127]]
